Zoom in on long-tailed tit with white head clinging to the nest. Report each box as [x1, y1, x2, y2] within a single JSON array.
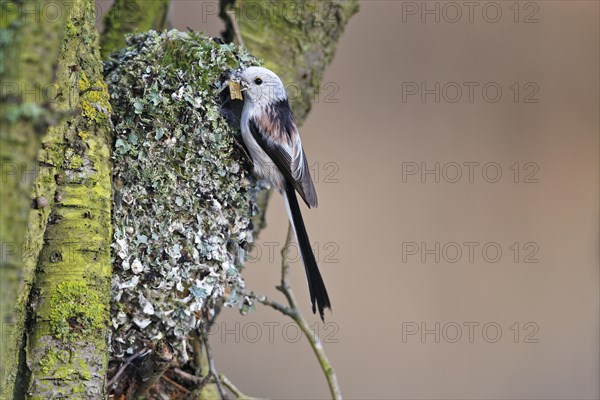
[[238, 67, 331, 319]]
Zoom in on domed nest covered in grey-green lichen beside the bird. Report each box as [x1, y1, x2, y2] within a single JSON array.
[[106, 31, 257, 359]]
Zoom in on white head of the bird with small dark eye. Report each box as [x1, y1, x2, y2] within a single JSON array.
[[239, 67, 287, 105]]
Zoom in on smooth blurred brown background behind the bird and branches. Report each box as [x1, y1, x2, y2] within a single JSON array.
[[99, 0, 600, 399]]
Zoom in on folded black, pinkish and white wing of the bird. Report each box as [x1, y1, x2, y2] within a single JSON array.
[[248, 102, 318, 208]]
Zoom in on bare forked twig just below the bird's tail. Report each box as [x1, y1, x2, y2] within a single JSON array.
[[248, 224, 342, 400]]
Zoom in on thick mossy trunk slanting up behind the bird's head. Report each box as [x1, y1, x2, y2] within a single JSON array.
[[220, 0, 358, 124]]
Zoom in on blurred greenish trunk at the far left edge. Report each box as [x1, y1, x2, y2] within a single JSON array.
[[0, 0, 65, 398]]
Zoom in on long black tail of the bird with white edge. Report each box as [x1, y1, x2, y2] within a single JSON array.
[[285, 184, 331, 320]]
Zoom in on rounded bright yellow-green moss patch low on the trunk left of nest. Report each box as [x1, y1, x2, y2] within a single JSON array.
[[50, 281, 106, 342]]
